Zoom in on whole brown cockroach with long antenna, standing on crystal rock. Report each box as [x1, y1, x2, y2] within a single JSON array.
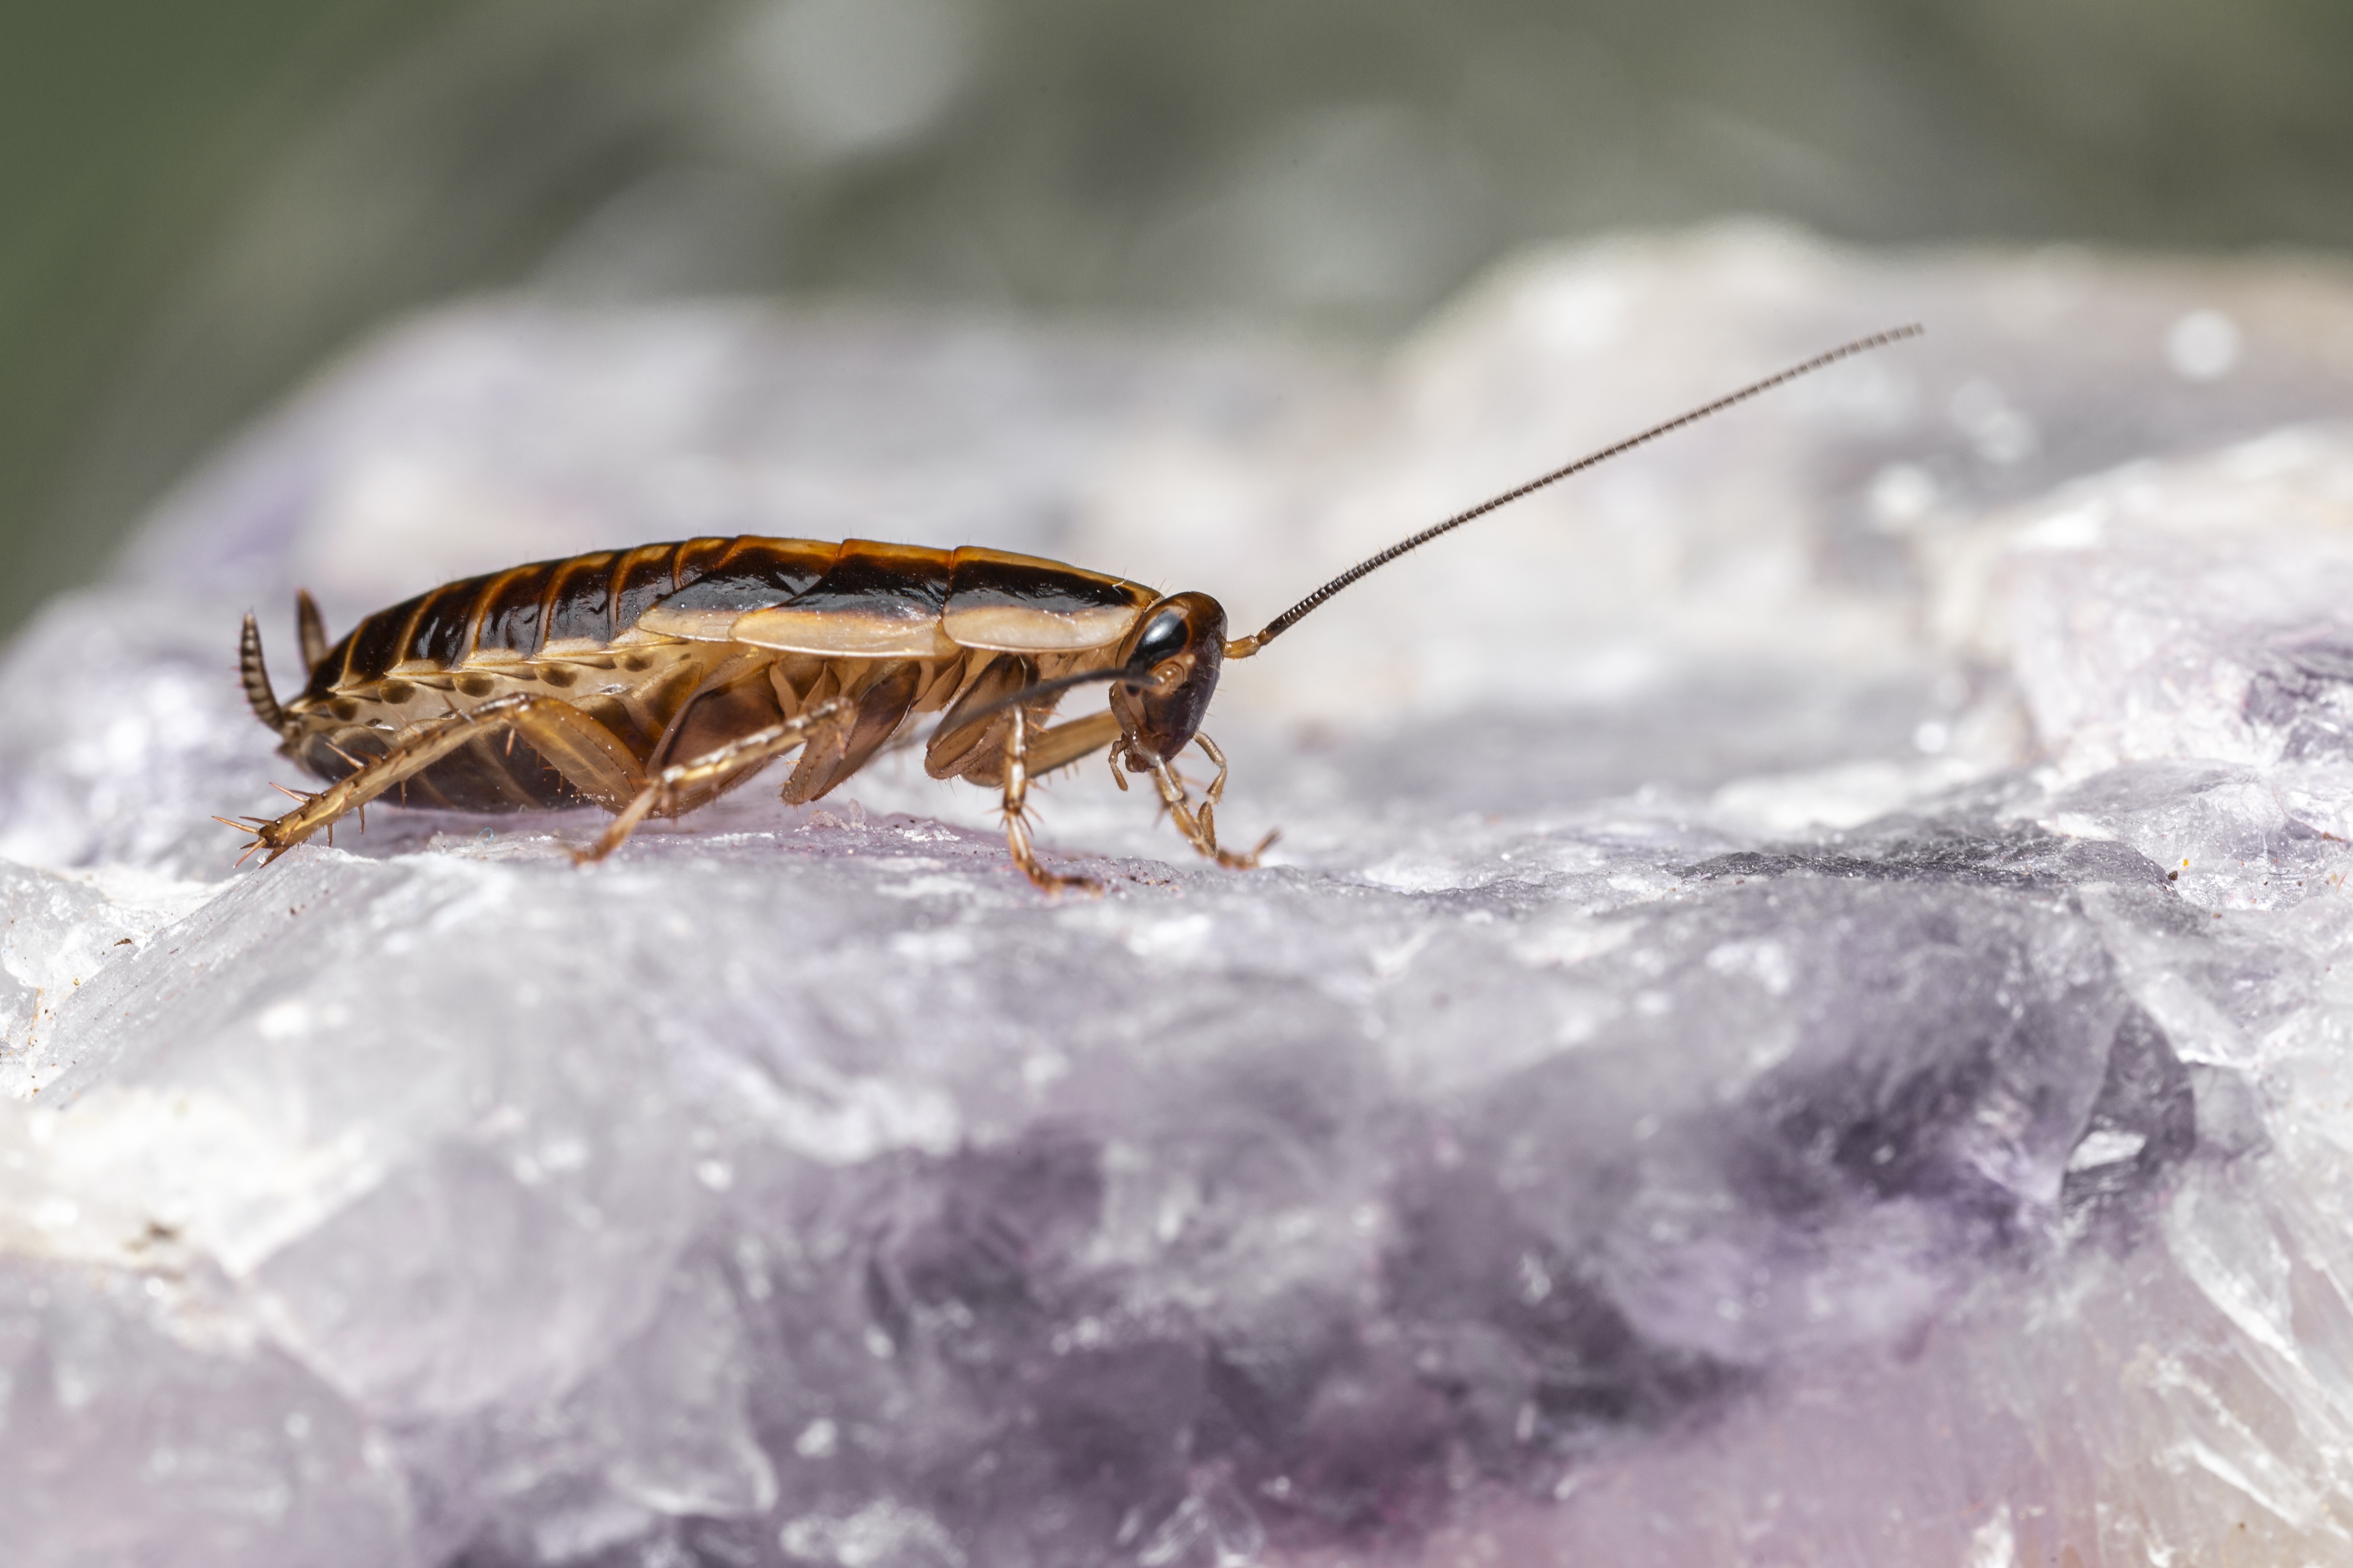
[[219, 327, 1920, 891]]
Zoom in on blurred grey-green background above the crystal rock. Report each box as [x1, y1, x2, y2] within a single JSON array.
[[0, 0, 2353, 625]]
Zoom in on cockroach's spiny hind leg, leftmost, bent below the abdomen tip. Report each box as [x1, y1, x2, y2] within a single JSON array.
[[216, 691, 645, 865]]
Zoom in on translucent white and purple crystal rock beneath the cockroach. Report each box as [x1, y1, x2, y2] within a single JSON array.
[[0, 228, 2353, 1568]]
